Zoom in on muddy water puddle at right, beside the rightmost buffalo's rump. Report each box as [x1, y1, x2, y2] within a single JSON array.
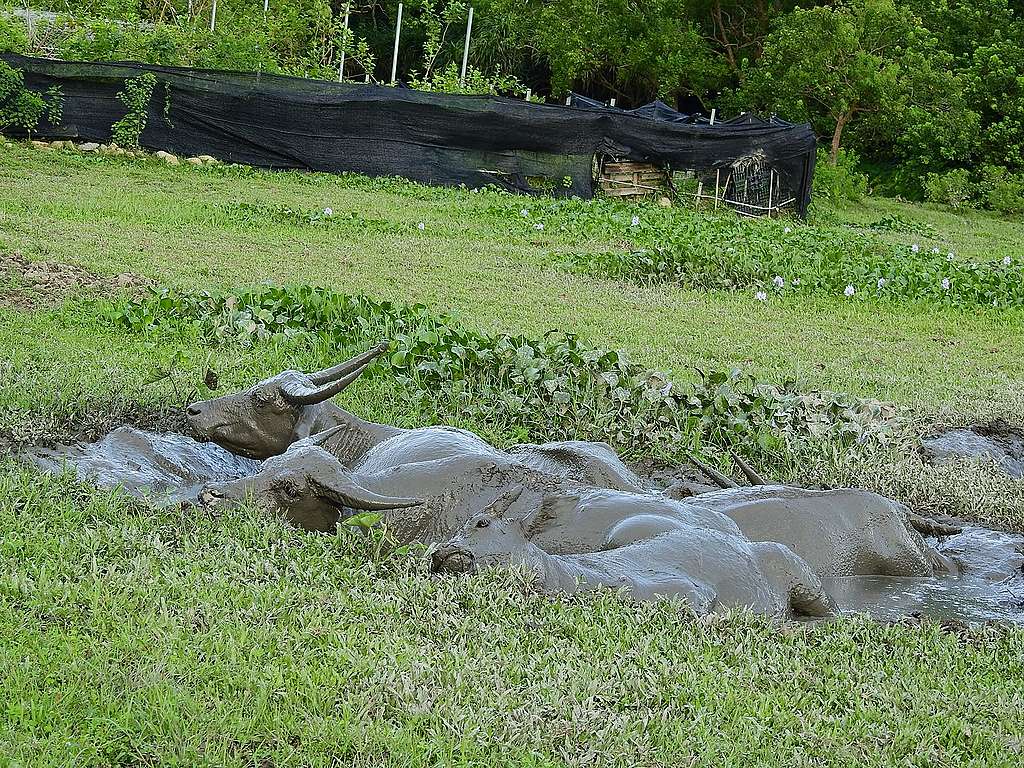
[[822, 527, 1024, 623]]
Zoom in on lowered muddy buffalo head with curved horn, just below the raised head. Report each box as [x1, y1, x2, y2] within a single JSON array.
[[199, 440, 423, 531]]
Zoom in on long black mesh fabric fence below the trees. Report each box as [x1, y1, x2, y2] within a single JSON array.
[[0, 54, 815, 215]]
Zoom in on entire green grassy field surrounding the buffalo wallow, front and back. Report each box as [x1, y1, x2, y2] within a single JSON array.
[[6, 144, 1024, 766]]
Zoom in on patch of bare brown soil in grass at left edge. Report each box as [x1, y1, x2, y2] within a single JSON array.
[[0, 253, 152, 309]]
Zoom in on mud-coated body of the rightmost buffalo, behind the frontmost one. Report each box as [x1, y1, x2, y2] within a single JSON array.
[[686, 485, 956, 577]]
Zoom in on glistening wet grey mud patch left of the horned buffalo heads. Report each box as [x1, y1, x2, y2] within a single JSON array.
[[29, 427, 261, 504]]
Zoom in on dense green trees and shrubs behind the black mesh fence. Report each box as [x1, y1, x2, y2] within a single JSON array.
[[8, 0, 1024, 205]]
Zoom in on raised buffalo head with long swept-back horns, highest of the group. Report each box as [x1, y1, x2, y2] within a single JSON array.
[[185, 344, 388, 459]]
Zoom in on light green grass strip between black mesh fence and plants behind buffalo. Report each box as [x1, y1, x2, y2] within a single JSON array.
[[0, 141, 1024, 412]]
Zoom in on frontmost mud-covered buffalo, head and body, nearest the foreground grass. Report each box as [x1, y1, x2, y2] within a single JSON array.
[[431, 511, 835, 617]]
